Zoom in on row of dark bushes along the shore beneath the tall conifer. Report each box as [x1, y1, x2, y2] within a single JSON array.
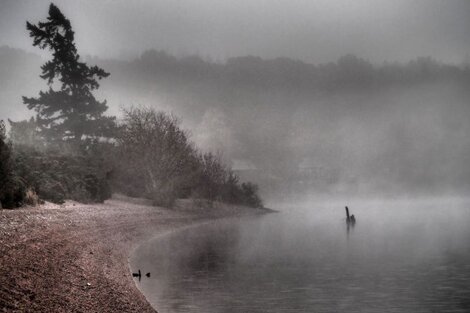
[[0, 108, 262, 207]]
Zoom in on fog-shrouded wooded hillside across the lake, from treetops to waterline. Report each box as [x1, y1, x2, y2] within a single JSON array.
[[0, 44, 470, 199]]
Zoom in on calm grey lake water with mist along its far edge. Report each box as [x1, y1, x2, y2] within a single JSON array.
[[131, 199, 470, 313]]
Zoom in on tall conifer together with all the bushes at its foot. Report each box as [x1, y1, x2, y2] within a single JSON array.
[[0, 4, 263, 208]]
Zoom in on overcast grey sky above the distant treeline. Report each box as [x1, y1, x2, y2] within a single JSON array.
[[0, 0, 470, 63]]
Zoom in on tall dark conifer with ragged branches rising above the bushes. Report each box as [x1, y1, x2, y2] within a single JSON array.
[[23, 3, 115, 146]]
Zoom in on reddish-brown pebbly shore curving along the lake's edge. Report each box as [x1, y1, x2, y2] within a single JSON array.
[[0, 197, 268, 312]]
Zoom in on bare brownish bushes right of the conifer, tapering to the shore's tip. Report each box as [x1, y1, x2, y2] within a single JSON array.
[[110, 108, 262, 207]]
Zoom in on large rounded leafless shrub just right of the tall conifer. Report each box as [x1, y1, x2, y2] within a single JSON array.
[[115, 108, 197, 206]]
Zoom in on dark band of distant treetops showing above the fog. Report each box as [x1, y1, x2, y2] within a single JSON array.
[[103, 50, 470, 92]]
